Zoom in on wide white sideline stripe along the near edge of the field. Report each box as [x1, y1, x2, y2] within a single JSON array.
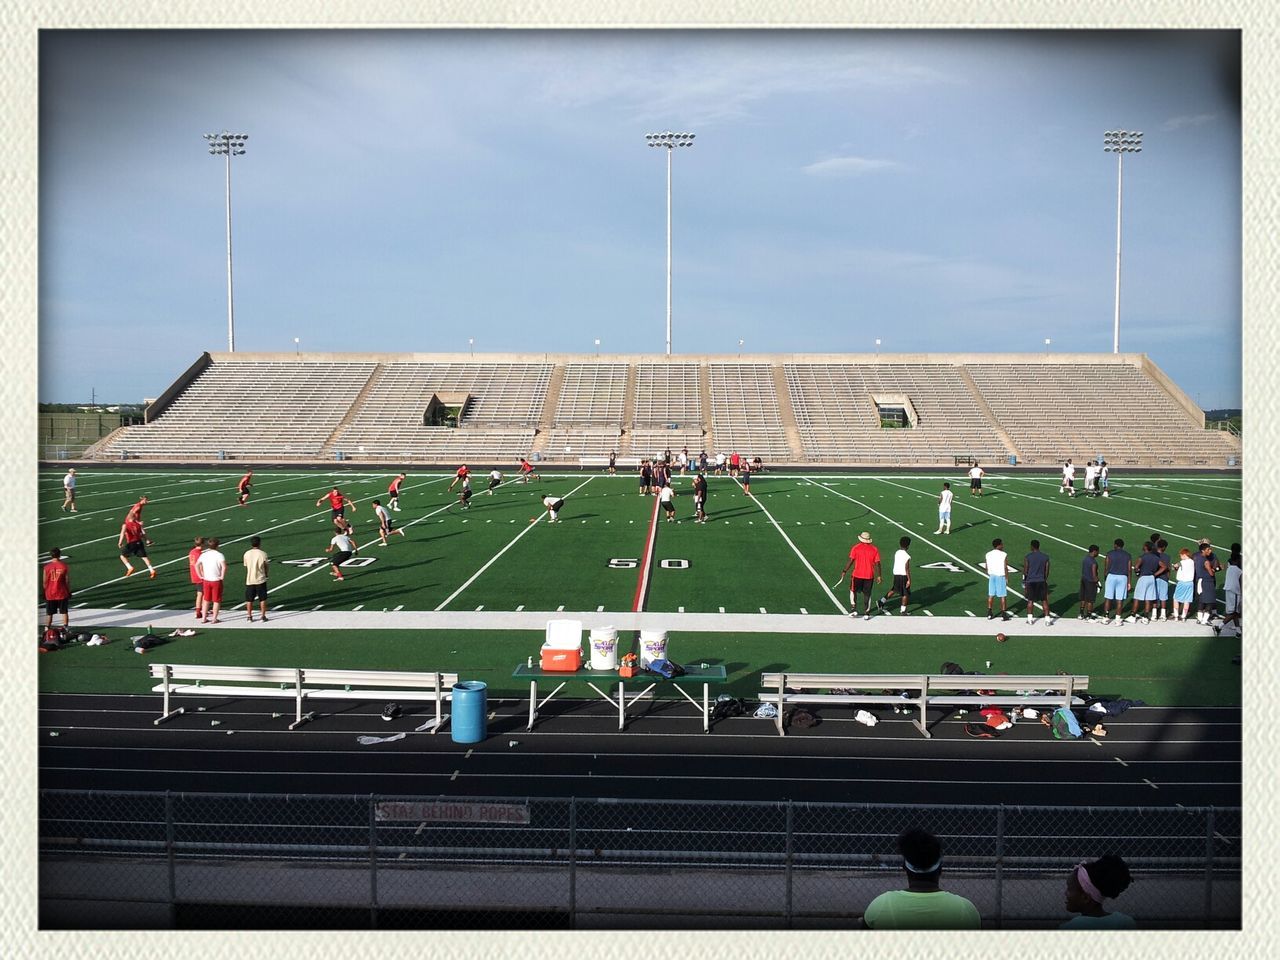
[[72, 605, 1212, 639]]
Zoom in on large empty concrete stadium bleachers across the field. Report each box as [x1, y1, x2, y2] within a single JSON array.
[[84, 353, 1240, 467]]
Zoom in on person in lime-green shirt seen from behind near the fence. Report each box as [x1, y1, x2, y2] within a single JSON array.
[[863, 827, 982, 931]]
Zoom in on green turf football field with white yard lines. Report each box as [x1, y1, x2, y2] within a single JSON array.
[[40, 468, 1242, 704]]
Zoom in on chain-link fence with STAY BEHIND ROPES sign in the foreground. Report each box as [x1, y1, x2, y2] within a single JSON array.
[[40, 790, 1242, 929]]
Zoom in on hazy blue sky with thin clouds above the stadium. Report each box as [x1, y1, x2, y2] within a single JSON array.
[[40, 31, 1242, 407]]
